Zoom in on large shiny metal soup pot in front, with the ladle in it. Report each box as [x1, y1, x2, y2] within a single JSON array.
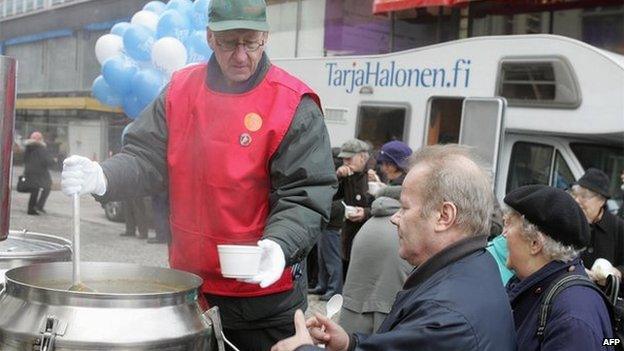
[[0, 262, 222, 351]]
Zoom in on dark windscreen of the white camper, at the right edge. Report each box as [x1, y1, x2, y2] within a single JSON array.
[[570, 143, 624, 199]]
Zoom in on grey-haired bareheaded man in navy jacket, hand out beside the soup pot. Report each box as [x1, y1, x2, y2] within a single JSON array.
[[272, 144, 516, 351]]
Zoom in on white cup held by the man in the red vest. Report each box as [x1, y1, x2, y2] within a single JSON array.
[[217, 245, 262, 279]]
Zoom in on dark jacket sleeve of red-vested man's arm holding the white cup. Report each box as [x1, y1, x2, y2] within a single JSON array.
[[264, 96, 338, 265]]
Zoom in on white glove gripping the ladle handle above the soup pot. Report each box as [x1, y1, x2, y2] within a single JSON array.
[[61, 155, 106, 196]]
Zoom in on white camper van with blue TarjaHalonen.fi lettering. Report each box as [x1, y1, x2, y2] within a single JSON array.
[[273, 35, 624, 206]]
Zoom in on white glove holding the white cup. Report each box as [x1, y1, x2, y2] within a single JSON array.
[[243, 239, 286, 288]]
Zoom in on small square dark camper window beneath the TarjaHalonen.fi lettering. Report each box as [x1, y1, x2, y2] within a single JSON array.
[[355, 105, 408, 149]]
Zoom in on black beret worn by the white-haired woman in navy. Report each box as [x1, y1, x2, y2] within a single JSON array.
[[503, 185, 589, 249]]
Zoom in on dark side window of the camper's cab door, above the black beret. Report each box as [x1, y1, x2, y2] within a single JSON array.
[[506, 142, 554, 193]]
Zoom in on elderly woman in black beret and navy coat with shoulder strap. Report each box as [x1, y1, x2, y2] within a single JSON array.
[[503, 185, 613, 351]]
